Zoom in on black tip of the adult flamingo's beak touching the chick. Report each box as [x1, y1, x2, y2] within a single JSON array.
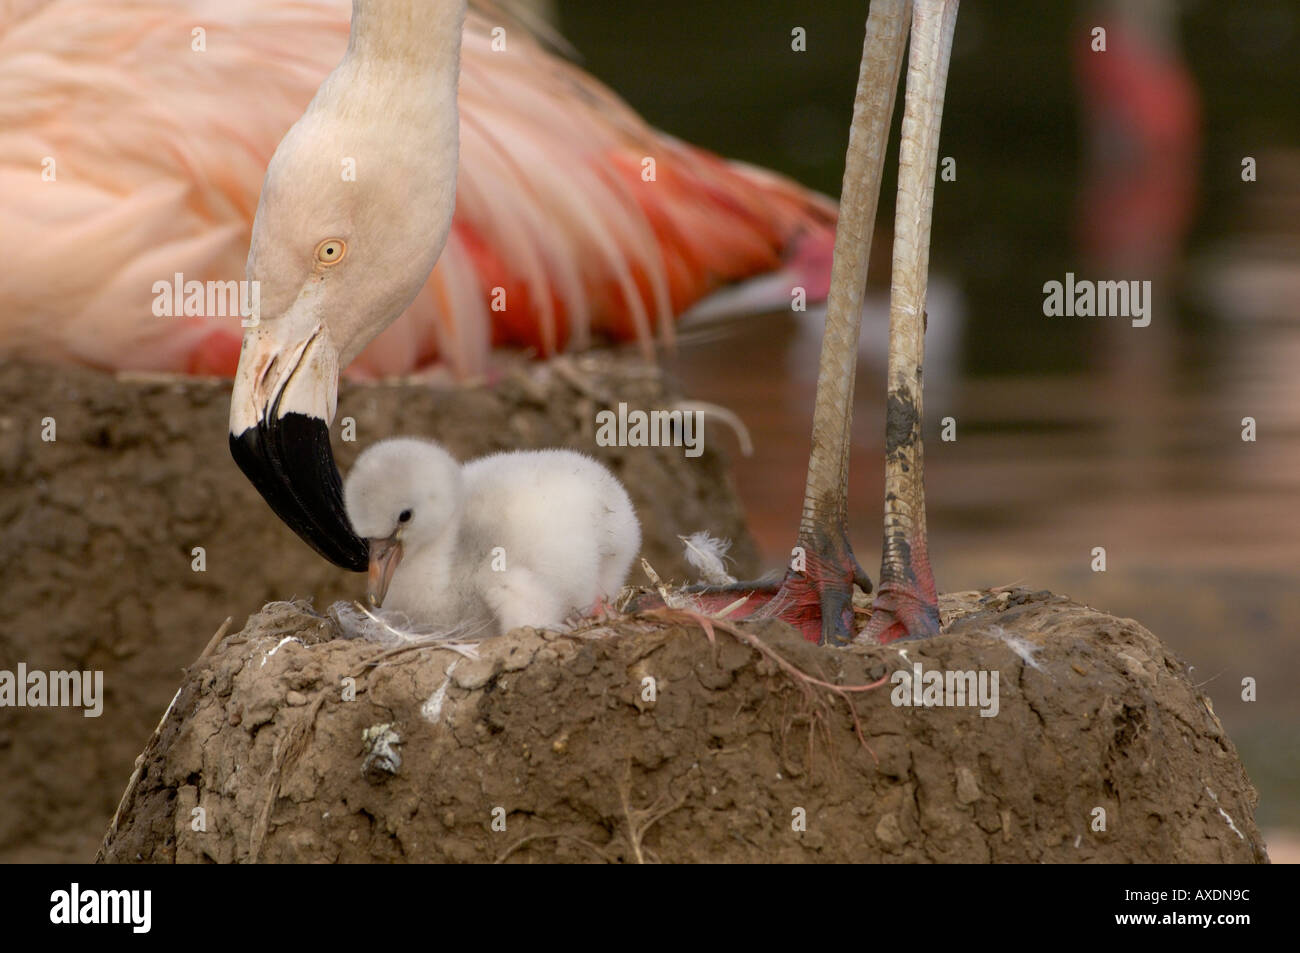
[[230, 412, 369, 572]]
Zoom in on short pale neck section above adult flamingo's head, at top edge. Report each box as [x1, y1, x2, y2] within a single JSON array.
[[347, 0, 467, 72]]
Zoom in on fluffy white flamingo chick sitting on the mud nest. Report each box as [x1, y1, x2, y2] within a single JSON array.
[[343, 437, 641, 634]]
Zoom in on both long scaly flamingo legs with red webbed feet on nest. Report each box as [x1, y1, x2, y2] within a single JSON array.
[[637, 0, 958, 645]]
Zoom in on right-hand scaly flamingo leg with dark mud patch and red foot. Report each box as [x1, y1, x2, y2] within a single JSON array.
[[861, 0, 958, 642]]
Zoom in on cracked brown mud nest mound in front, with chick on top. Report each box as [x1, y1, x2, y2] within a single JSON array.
[[100, 590, 1268, 862]]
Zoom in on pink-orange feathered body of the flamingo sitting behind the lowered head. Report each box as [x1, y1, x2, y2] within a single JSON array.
[[0, 0, 835, 377]]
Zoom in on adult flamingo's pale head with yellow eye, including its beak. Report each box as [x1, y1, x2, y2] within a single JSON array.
[[230, 44, 459, 572]]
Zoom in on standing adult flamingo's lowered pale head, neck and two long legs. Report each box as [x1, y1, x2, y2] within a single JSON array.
[[230, 0, 957, 642]]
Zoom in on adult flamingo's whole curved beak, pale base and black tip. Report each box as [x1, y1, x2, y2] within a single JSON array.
[[230, 294, 369, 572]]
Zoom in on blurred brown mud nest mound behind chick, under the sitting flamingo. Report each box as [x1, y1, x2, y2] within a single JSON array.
[[0, 356, 755, 862]]
